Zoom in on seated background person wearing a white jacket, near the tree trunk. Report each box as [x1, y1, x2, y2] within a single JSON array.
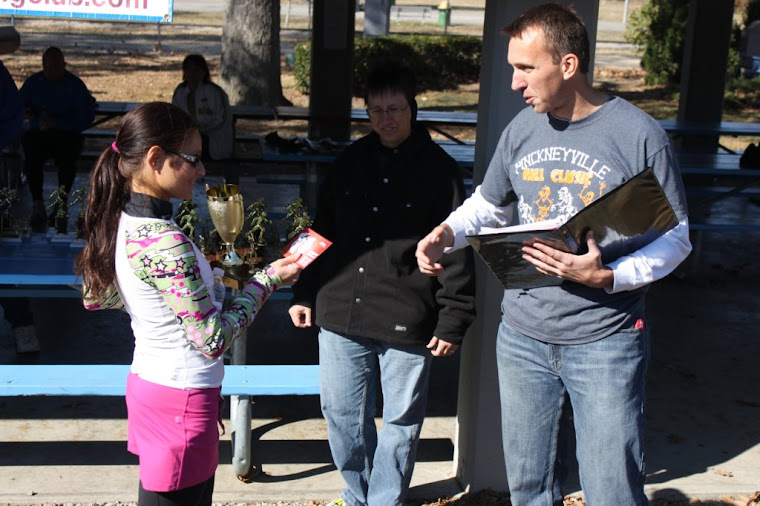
[[172, 54, 235, 160]]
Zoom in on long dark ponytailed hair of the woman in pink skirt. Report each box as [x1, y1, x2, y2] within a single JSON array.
[[74, 102, 198, 298]]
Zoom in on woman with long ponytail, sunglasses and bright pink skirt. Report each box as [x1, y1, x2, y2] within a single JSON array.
[[76, 102, 300, 506]]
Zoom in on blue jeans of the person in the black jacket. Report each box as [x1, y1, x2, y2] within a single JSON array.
[[319, 329, 432, 506]]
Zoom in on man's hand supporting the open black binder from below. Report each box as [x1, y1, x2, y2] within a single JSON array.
[[522, 231, 615, 288]]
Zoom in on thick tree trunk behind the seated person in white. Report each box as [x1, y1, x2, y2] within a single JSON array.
[[219, 0, 289, 107]]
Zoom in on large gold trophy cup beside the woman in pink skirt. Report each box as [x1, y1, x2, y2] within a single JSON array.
[[206, 184, 250, 278]]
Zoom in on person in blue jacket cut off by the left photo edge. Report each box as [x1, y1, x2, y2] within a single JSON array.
[[0, 56, 40, 353]]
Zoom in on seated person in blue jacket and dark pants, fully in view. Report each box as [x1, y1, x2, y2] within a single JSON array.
[[21, 47, 95, 232]]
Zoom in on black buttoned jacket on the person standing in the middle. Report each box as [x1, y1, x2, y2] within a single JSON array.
[[293, 125, 475, 344]]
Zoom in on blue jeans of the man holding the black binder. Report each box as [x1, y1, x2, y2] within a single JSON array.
[[496, 322, 649, 506]]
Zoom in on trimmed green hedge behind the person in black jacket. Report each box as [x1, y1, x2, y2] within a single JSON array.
[[293, 35, 483, 97]]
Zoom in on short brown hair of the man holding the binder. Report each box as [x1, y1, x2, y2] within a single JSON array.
[[501, 3, 591, 74]]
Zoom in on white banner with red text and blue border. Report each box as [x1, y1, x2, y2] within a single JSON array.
[[0, 0, 174, 23]]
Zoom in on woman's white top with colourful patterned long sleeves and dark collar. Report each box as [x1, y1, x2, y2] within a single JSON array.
[[84, 193, 282, 388]]
